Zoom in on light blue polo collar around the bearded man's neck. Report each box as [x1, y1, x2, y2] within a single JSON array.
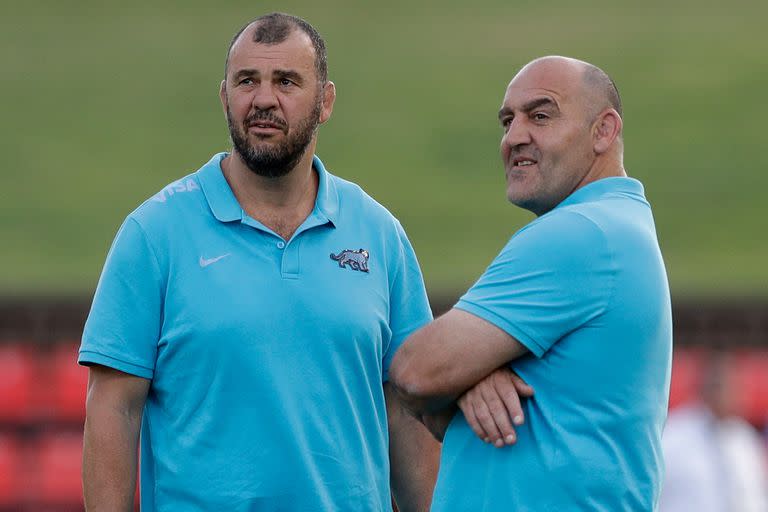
[[197, 153, 339, 225]]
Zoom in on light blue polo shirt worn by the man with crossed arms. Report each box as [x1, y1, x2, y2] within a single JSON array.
[[432, 178, 672, 512]]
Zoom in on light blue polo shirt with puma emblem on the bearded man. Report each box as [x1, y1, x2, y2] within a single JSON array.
[[79, 153, 431, 512]]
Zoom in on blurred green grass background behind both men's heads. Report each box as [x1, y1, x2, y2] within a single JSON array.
[[0, 0, 768, 297]]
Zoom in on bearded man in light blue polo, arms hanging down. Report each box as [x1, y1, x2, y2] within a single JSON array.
[[79, 14, 438, 512]]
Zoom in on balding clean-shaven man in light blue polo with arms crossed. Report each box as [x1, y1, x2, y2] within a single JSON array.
[[390, 57, 672, 512]]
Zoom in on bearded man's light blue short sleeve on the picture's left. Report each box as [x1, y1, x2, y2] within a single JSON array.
[[78, 217, 164, 379]]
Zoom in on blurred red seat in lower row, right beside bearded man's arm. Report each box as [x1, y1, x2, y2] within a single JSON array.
[[33, 432, 83, 506]]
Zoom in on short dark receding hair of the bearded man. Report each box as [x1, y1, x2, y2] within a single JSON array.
[[224, 12, 328, 84]]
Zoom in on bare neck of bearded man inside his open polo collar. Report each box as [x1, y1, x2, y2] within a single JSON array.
[[221, 141, 318, 240]]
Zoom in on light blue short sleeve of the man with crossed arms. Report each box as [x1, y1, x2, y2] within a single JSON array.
[[456, 211, 616, 357]]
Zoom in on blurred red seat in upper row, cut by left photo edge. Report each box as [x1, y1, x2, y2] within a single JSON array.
[[0, 343, 36, 423]]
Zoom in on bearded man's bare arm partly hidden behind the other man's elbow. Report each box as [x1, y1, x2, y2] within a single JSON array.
[[387, 389, 440, 512]]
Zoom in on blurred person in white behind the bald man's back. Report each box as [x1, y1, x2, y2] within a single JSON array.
[[659, 350, 768, 512]]
